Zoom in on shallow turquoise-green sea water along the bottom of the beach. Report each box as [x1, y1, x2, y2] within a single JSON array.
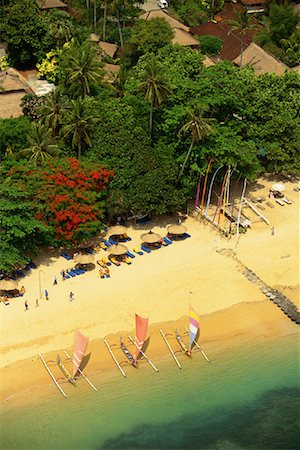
[[1, 335, 300, 450]]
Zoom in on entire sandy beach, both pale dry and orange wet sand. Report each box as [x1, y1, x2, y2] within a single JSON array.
[[0, 179, 300, 400]]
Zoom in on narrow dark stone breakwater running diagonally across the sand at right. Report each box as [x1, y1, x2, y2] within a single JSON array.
[[216, 248, 300, 325]]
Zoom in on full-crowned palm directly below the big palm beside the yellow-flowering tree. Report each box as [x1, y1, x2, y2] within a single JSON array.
[[62, 97, 98, 158]]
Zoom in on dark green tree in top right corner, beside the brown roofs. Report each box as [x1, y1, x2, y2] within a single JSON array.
[[269, 3, 299, 45]]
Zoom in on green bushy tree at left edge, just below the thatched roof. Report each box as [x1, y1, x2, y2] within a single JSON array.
[[0, 117, 32, 160]]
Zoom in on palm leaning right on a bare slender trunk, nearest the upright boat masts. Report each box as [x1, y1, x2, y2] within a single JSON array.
[[179, 105, 216, 176]]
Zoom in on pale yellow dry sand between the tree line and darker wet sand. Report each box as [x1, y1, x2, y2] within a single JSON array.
[[0, 176, 300, 366]]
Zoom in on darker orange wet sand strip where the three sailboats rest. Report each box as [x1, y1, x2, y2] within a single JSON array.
[[0, 301, 299, 406]]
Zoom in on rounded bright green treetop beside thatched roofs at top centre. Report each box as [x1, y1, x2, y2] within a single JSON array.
[[130, 18, 174, 55]]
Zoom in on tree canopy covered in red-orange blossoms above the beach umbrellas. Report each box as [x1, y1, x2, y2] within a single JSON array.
[[35, 158, 113, 243]]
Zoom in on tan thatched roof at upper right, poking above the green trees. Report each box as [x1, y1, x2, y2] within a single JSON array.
[[233, 42, 289, 75]]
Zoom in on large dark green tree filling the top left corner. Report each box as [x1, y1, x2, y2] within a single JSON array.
[[0, 0, 51, 67]]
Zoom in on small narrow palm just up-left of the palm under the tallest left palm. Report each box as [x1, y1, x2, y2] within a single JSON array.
[[41, 89, 66, 136]]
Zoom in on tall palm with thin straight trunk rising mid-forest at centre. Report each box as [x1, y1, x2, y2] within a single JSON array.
[[138, 59, 172, 136]]
